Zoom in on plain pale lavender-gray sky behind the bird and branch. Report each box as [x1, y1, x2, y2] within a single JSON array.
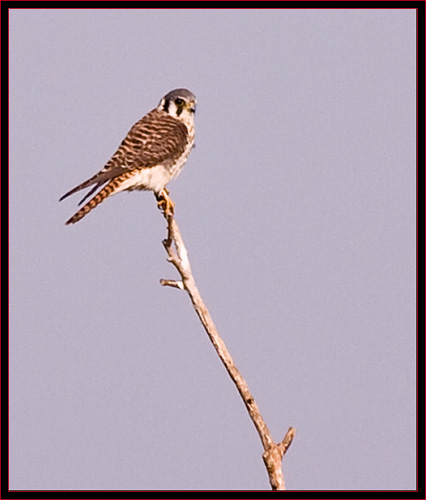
[[9, 9, 416, 490]]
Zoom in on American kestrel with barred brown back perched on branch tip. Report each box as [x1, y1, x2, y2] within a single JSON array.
[[59, 89, 196, 224]]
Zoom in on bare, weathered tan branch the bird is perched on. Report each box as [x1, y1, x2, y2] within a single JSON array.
[[160, 202, 296, 490]]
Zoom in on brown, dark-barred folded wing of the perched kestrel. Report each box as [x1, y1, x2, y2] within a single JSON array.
[[59, 109, 188, 203]]
